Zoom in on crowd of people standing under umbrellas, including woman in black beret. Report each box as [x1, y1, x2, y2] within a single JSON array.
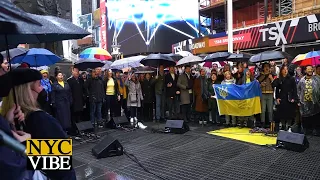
[[0, 52, 320, 179]]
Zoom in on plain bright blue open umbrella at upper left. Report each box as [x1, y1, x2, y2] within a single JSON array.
[[11, 48, 61, 67]]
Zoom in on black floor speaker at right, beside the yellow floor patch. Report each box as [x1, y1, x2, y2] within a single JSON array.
[[277, 131, 309, 152]]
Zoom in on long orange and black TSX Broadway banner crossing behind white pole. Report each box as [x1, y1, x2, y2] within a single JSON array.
[[172, 14, 320, 54]]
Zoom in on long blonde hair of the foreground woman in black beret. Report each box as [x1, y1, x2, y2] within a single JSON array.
[[0, 82, 40, 117]]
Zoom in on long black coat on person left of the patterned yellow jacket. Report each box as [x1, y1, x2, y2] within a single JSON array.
[[273, 75, 298, 120]]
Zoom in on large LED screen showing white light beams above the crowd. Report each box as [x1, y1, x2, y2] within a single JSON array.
[[106, 0, 199, 55]]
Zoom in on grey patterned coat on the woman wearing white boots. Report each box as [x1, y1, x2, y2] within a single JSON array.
[[126, 81, 143, 107]]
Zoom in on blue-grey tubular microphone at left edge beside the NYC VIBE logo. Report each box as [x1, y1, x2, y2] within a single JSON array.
[[0, 129, 26, 155]]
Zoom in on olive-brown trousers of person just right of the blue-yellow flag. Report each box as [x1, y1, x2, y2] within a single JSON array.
[[261, 93, 273, 123]]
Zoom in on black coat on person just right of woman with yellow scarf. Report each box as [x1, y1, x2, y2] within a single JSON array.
[[67, 77, 84, 112]]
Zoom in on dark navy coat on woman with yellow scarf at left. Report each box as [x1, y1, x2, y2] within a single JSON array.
[[51, 82, 72, 130]]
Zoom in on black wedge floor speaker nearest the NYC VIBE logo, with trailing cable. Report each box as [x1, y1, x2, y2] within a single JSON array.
[[92, 135, 123, 159]]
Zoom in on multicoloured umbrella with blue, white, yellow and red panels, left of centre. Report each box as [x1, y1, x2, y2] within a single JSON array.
[[79, 47, 112, 60]]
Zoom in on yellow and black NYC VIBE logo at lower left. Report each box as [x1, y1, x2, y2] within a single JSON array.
[[26, 139, 72, 170]]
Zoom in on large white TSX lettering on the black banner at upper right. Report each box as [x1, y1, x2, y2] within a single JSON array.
[[259, 21, 288, 46]]
